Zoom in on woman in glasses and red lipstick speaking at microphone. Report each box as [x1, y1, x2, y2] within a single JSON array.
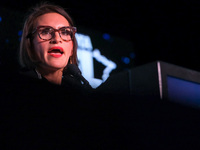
[[19, 3, 90, 91]]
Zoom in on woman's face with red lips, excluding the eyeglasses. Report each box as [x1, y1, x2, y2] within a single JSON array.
[[33, 13, 73, 70]]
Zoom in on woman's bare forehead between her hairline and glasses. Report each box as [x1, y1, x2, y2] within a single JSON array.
[[36, 13, 69, 28]]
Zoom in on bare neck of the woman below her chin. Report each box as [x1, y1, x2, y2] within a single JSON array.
[[36, 67, 63, 85]]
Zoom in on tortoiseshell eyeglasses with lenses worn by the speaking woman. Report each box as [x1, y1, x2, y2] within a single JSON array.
[[27, 26, 77, 41]]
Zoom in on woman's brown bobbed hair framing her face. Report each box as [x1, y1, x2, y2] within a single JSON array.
[[19, 2, 78, 69]]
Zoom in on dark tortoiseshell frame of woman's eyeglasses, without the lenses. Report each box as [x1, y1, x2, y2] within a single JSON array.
[[27, 26, 77, 41]]
